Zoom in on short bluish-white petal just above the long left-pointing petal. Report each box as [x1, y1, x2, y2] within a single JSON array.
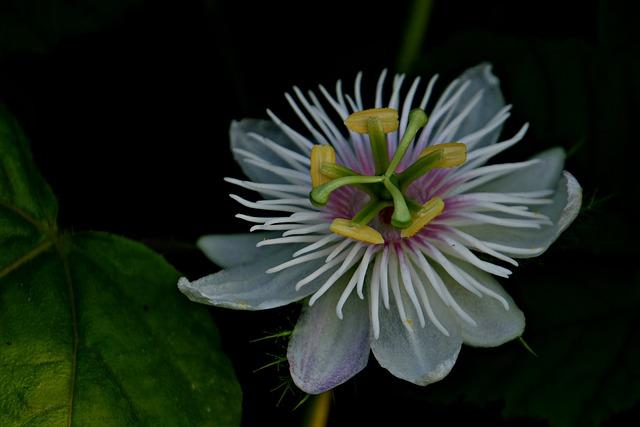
[[197, 233, 281, 268]]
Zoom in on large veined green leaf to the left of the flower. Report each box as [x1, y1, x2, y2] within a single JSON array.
[[0, 109, 241, 426]]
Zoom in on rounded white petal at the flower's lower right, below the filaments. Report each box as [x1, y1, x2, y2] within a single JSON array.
[[438, 261, 525, 347]]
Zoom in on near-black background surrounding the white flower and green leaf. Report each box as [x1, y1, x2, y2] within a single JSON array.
[[0, 0, 640, 425]]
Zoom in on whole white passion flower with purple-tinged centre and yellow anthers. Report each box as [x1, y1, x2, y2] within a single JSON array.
[[178, 64, 581, 394]]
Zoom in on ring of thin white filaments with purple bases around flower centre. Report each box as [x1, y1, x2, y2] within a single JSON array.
[[225, 70, 554, 339]]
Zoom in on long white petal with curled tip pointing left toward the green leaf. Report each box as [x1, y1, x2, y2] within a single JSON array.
[[178, 244, 333, 310]]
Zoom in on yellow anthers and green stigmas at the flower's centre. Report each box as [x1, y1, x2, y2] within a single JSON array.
[[309, 108, 467, 244]]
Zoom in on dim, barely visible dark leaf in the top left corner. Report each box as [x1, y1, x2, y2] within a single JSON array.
[[0, 0, 142, 55]]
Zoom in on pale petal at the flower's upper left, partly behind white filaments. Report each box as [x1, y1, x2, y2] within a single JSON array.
[[229, 119, 300, 184]]
